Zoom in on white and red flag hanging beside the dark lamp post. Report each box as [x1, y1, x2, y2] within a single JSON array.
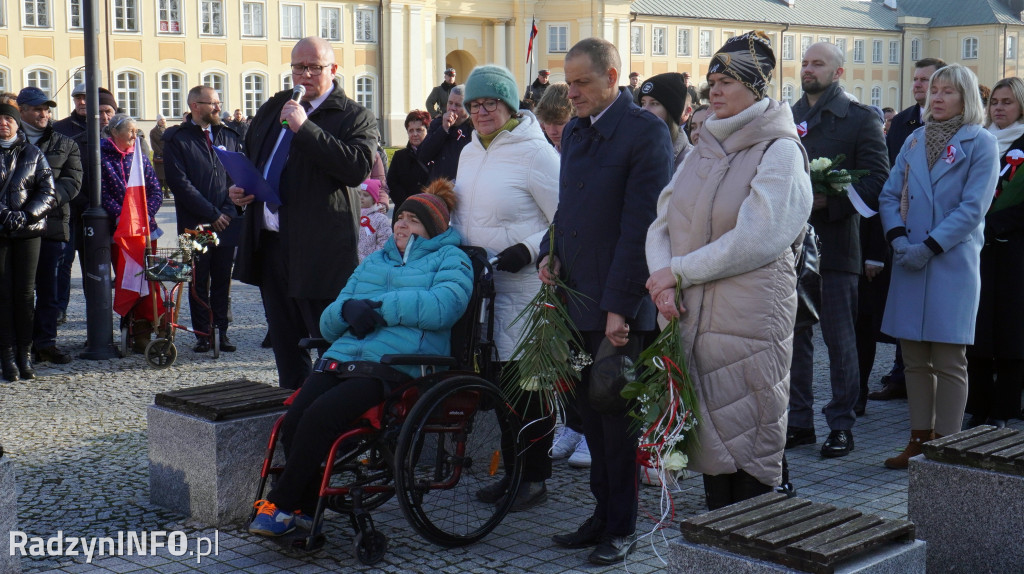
[[114, 144, 150, 316]]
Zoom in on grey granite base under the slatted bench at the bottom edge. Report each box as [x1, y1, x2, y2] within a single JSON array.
[[667, 538, 931, 574]]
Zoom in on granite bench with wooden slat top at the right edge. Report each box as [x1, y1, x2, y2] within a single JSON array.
[[907, 426, 1024, 573]]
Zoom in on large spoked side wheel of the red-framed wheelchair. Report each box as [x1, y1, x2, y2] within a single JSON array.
[[395, 377, 522, 547]]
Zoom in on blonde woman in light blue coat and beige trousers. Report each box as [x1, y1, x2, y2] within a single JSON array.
[[879, 64, 999, 469]]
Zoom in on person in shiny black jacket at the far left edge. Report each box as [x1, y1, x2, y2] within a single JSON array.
[[0, 103, 57, 381]]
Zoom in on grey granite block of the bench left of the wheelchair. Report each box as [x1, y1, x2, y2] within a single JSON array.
[[147, 405, 285, 526]]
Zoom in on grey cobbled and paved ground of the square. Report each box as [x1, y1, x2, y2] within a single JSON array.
[[0, 198, 1024, 573]]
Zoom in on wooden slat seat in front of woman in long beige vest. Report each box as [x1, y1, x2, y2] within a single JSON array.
[[673, 492, 924, 574]]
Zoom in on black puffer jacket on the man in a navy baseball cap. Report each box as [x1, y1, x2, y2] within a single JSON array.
[[36, 125, 82, 241]]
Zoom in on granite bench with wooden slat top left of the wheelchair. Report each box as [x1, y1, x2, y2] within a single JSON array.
[[147, 380, 292, 526]]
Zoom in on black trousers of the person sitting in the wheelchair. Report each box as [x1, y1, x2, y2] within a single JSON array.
[[266, 372, 387, 516]]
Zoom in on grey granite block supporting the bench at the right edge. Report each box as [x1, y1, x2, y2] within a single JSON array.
[[907, 456, 1024, 573]]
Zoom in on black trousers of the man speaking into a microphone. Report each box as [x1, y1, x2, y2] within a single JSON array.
[[259, 231, 332, 389]]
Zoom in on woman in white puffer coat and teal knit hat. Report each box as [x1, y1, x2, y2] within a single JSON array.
[[452, 65, 559, 512]]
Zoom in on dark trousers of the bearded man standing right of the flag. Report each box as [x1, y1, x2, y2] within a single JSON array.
[[188, 226, 236, 337]]
